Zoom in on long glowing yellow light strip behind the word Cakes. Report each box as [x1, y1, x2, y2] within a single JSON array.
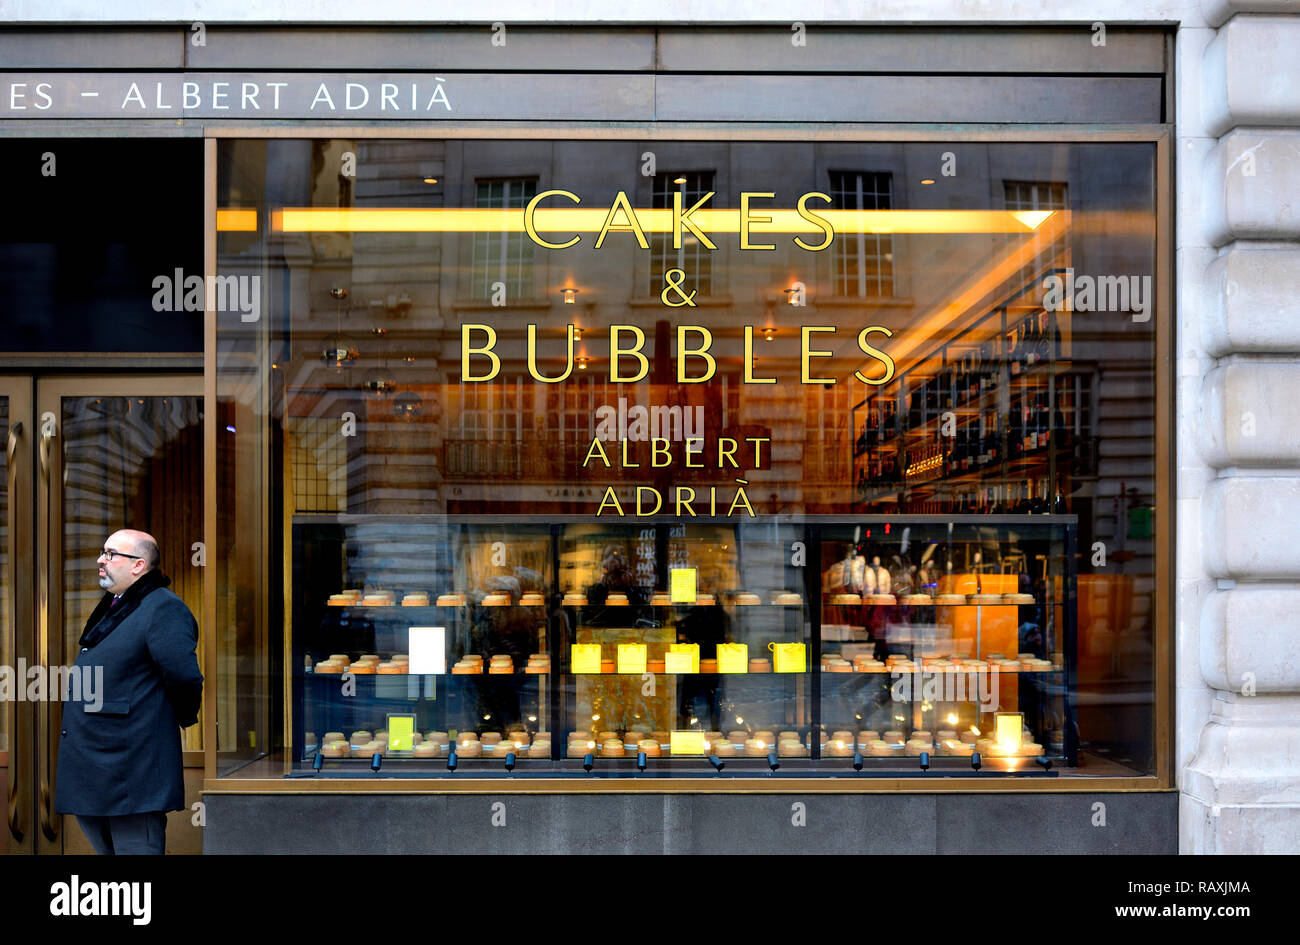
[[266, 207, 1054, 238]]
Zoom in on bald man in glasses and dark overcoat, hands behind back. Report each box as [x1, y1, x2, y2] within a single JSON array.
[[55, 529, 203, 854]]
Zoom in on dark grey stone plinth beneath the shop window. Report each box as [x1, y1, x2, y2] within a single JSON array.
[[203, 792, 1178, 854]]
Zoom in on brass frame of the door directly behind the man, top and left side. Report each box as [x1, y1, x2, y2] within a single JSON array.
[[34, 374, 203, 853]]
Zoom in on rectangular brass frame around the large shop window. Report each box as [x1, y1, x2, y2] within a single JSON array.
[[203, 124, 1177, 794]]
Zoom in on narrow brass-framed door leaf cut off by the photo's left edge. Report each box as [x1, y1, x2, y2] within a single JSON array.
[[0, 377, 36, 853]]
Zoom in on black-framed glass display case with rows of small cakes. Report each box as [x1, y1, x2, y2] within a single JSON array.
[[290, 515, 1079, 777]]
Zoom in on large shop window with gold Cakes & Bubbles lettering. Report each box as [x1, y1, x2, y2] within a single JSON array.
[[217, 135, 1169, 777]]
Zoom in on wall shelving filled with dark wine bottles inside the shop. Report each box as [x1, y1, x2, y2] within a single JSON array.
[[853, 266, 1093, 515]]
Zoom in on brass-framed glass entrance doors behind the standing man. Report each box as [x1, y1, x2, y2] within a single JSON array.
[[0, 376, 204, 853]]
